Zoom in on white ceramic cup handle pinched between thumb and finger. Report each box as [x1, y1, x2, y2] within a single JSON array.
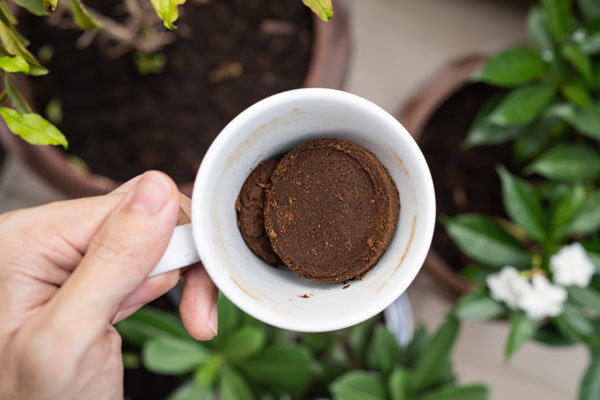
[[148, 224, 200, 276]]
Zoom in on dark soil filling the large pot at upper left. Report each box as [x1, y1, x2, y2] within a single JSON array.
[[27, 0, 312, 182]]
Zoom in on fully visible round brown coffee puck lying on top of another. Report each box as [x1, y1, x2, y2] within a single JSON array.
[[264, 139, 400, 282]]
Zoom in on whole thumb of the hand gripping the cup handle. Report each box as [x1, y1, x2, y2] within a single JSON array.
[[52, 171, 179, 338]]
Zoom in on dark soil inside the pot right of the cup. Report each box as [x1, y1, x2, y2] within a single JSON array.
[[420, 84, 515, 269]]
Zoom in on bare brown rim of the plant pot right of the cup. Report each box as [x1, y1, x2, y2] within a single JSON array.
[[398, 55, 487, 298]]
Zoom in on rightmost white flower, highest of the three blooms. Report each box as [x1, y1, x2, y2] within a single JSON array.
[[550, 243, 596, 287]]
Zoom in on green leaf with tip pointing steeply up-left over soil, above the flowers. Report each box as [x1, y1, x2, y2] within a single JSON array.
[[498, 167, 547, 242]]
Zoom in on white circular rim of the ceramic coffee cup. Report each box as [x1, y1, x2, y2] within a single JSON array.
[[192, 88, 436, 332]]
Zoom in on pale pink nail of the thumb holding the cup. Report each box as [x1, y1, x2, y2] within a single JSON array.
[[129, 172, 171, 214]]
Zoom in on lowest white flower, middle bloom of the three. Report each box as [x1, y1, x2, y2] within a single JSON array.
[[517, 275, 567, 320]]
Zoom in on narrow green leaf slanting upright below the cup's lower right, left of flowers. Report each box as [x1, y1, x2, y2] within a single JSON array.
[[414, 315, 459, 390]]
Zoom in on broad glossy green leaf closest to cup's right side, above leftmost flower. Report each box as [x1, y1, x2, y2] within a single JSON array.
[[442, 214, 531, 267]]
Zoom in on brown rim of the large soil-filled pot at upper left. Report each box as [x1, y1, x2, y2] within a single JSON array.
[[0, 0, 350, 197]]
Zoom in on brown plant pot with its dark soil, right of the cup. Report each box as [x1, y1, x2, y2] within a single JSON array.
[[398, 55, 514, 298]]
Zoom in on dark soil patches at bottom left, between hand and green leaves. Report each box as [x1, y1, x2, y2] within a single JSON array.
[[123, 296, 184, 400]]
